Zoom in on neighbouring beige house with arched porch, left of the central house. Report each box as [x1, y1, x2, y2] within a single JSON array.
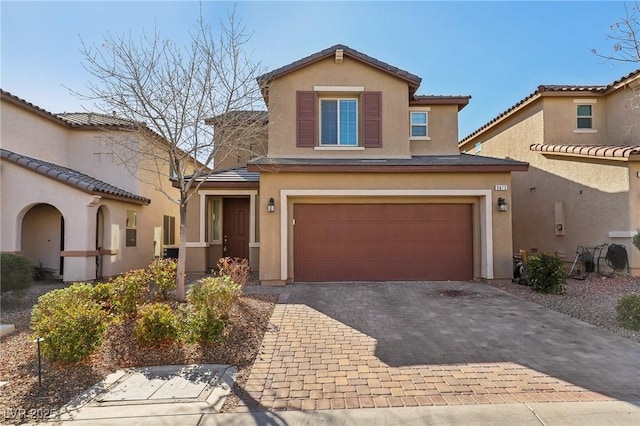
[[0, 91, 179, 281]]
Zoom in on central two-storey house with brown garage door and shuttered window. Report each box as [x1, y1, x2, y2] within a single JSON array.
[[182, 45, 527, 284]]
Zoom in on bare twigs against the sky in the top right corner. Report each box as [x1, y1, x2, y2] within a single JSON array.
[[591, 1, 640, 62]]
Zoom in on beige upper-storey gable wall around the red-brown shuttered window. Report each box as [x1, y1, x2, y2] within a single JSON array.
[[268, 57, 410, 158]]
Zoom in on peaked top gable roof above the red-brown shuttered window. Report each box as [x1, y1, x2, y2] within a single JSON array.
[[256, 44, 422, 93]]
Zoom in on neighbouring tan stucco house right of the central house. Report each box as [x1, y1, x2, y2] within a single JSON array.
[[460, 70, 640, 275]]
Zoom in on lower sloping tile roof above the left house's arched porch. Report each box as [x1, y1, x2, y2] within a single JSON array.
[[0, 149, 151, 204]]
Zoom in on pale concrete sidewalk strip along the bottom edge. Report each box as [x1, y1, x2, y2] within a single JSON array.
[[46, 401, 640, 426]]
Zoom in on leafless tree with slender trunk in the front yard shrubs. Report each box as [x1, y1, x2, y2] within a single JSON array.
[[76, 10, 264, 300]]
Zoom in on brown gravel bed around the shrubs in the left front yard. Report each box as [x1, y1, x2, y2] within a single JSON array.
[[0, 277, 277, 423]]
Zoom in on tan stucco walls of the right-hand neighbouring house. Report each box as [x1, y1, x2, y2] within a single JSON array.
[[463, 91, 640, 274]]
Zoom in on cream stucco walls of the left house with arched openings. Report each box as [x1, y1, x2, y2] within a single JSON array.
[[0, 101, 179, 281]]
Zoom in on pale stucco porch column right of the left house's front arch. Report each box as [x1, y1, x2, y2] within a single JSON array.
[[62, 197, 100, 282]]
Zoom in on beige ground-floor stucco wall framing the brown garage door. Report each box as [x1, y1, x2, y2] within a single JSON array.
[[260, 173, 512, 283]]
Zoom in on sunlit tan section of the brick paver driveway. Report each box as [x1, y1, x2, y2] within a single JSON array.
[[236, 304, 613, 411]]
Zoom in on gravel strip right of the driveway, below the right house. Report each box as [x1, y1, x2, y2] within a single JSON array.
[[493, 274, 640, 343]]
